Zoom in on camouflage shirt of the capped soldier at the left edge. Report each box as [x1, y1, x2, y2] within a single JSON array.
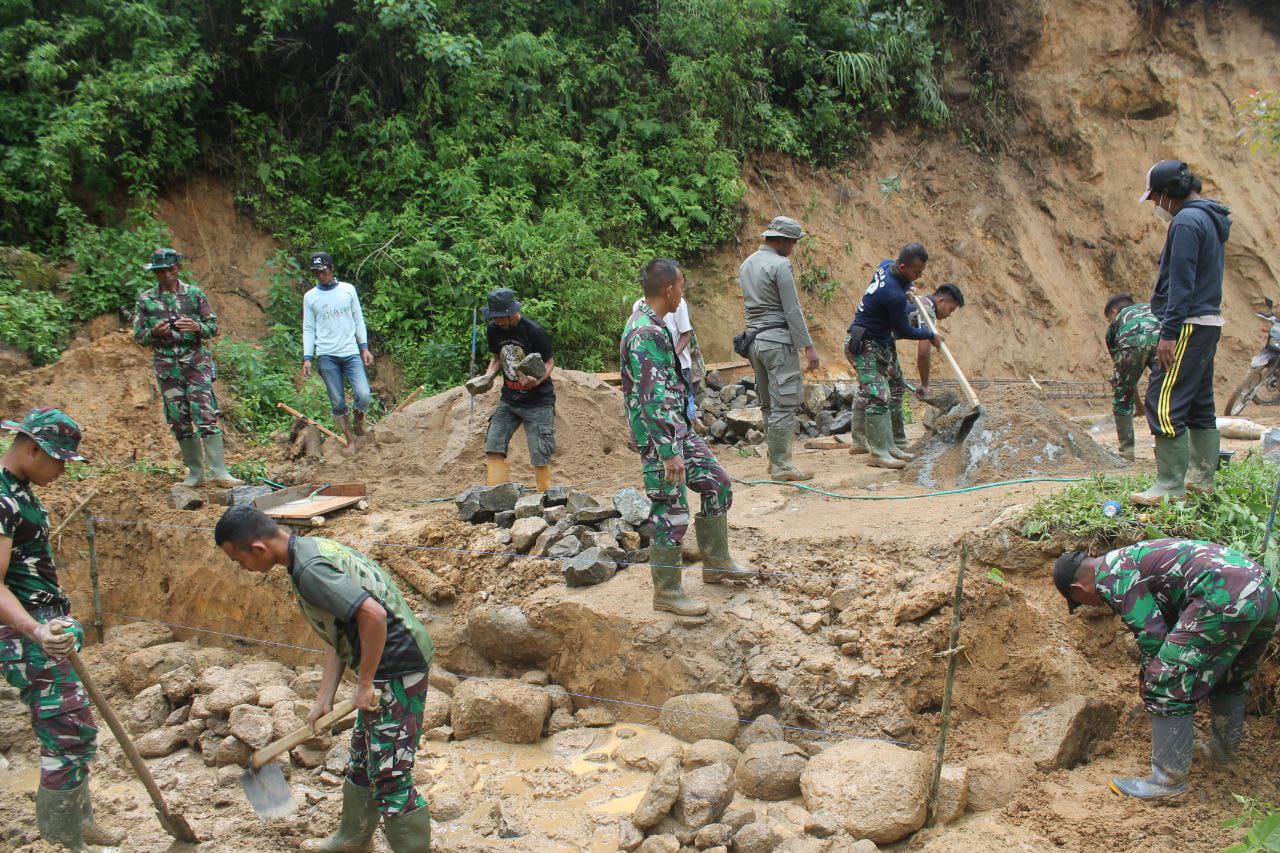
[[0, 467, 67, 610]]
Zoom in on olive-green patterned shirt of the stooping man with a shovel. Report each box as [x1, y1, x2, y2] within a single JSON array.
[[289, 535, 435, 681]]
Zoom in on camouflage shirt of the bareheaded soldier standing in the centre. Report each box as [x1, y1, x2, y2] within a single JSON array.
[[618, 302, 689, 465]]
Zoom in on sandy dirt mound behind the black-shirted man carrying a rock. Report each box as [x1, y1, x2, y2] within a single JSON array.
[[320, 370, 640, 498]]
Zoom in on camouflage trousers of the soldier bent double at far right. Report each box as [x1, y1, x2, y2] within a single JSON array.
[[1142, 584, 1280, 717]]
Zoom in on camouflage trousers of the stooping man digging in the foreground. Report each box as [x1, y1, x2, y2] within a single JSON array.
[[347, 672, 426, 817]]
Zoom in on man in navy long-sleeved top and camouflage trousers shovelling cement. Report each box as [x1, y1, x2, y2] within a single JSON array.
[[845, 243, 942, 467]]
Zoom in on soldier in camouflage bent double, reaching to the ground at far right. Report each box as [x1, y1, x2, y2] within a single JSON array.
[[1053, 539, 1280, 799]]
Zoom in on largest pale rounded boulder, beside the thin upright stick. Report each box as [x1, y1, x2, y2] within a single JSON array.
[[800, 740, 931, 844]]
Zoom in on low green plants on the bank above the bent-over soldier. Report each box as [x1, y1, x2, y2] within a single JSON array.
[[1023, 453, 1280, 576]]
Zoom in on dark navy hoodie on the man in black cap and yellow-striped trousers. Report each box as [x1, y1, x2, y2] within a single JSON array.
[[1151, 199, 1231, 341]]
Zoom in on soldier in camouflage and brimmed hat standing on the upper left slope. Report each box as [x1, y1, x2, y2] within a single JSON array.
[[133, 248, 241, 488]]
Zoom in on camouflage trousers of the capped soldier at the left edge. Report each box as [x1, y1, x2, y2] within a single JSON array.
[[0, 613, 97, 790]]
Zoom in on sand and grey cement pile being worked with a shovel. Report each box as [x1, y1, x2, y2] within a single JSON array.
[[904, 387, 1124, 488]]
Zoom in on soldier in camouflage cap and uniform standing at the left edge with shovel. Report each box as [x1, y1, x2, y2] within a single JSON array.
[[0, 407, 124, 850]]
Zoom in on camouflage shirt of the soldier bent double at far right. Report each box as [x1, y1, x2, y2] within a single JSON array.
[[1094, 539, 1271, 665]]
